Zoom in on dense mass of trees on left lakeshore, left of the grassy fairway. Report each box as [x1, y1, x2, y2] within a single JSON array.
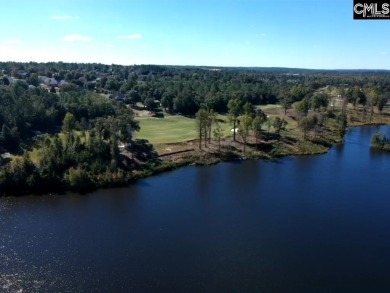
[[0, 75, 156, 194]]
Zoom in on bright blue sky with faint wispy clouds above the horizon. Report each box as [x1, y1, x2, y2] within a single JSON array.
[[0, 0, 390, 69]]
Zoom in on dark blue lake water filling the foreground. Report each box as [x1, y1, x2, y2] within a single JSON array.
[[0, 126, 390, 293]]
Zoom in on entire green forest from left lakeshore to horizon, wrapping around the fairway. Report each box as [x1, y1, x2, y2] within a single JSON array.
[[0, 62, 390, 195]]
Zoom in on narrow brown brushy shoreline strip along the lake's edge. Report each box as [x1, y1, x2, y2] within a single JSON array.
[[0, 123, 390, 198]]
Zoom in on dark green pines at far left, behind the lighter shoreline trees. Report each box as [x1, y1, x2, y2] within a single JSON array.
[[0, 81, 126, 152]]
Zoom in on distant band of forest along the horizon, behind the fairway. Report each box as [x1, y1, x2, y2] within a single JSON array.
[[0, 62, 390, 115]]
